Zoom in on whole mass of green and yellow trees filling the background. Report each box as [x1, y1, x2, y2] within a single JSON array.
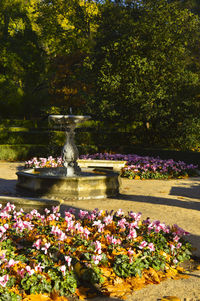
[[0, 0, 200, 149]]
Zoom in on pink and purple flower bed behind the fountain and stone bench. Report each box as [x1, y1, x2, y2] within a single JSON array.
[[25, 153, 198, 180]]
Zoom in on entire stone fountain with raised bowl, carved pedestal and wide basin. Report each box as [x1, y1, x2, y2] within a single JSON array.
[[17, 115, 119, 200]]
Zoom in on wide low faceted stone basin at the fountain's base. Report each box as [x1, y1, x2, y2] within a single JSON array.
[[17, 167, 119, 200]]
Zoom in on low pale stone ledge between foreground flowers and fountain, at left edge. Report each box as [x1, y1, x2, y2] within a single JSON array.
[[0, 196, 60, 214]]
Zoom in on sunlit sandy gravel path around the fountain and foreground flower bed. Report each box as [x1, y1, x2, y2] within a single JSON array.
[[0, 162, 200, 301]]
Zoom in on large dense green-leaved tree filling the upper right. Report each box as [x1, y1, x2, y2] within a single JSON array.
[[90, 0, 199, 148]]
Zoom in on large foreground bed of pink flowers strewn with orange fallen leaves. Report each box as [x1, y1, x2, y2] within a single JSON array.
[[0, 203, 191, 301]]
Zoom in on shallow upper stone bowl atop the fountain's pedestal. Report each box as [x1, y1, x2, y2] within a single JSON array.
[[48, 115, 91, 125]]
